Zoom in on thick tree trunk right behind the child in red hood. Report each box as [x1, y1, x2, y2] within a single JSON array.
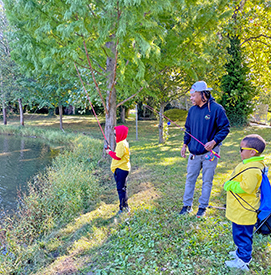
[[105, 42, 117, 150]]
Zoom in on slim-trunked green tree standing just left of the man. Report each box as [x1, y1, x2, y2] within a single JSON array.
[[133, 1, 232, 143]]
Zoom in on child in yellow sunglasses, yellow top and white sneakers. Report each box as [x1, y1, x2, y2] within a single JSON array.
[[224, 134, 266, 270]]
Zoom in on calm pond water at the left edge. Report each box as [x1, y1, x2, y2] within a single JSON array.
[[0, 135, 59, 216]]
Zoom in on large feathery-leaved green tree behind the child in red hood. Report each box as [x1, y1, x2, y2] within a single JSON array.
[[4, 0, 235, 147]]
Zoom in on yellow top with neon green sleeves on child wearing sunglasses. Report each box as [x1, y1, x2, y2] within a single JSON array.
[[224, 156, 264, 225]]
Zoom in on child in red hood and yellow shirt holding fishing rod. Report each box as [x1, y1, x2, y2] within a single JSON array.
[[106, 125, 131, 214]]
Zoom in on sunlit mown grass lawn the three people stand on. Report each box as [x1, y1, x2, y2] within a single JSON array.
[[0, 115, 271, 275]]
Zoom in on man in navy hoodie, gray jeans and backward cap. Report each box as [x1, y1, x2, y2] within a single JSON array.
[[180, 81, 230, 217]]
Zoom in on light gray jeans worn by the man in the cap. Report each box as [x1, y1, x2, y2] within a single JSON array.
[[183, 146, 220, 208]]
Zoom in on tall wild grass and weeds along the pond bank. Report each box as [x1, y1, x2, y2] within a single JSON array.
[[0, 129, 102, 274]]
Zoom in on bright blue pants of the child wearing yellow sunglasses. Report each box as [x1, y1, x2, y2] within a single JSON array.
[[232, 222, 254, 263]]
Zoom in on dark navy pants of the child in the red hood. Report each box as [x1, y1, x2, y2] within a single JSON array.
[[114, 168, 129, 210]]
